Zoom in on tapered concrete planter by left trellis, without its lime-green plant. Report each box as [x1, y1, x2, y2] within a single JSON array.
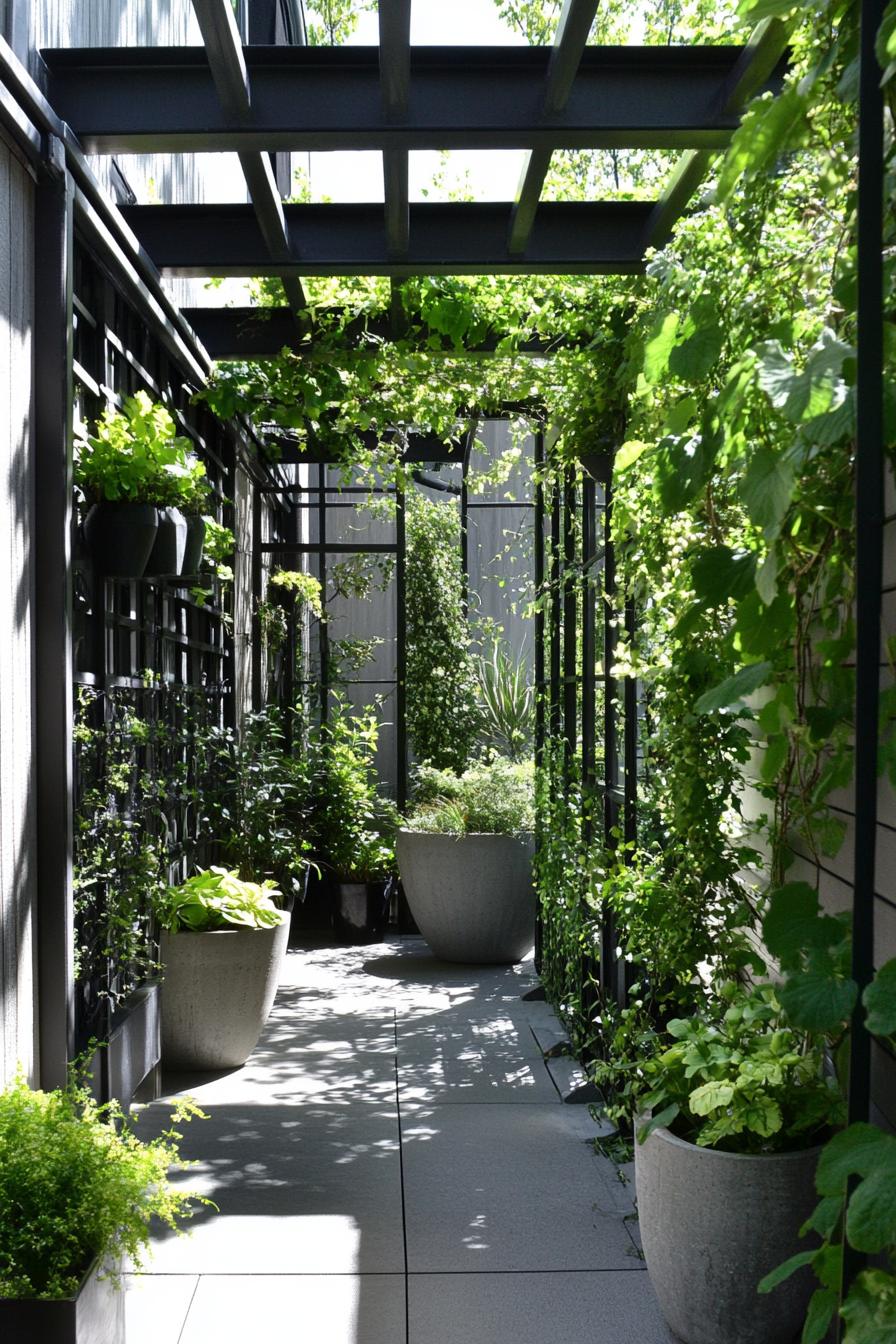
[[161, 915, 289, 1070]]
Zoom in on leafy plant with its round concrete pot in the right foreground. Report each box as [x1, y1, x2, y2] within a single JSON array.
[[635, 984, 842, 1344]]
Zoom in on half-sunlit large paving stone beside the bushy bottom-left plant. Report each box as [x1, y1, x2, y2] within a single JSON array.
[[140, 1102, 404, 1274]]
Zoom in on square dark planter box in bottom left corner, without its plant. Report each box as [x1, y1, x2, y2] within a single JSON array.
[[0, 1265, 125, 1344]]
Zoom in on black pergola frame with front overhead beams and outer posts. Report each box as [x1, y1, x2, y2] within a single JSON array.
[[0, 0, 883, 1279]]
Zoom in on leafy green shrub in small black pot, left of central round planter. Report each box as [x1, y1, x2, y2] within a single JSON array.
[[309, 699, 398, 942]]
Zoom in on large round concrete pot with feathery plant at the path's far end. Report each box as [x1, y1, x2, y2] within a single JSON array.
[[395, 757, 535, 962]]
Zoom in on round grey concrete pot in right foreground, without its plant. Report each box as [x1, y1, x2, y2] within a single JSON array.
[[635, 1129, 821, 1344]]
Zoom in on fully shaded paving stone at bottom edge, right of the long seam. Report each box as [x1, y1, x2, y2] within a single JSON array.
[[407, 1270, 674, 1344]]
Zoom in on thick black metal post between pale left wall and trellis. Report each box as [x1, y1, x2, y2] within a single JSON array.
[[34, 136, 75, 1089]]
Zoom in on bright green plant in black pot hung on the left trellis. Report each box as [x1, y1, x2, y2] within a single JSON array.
[[75, 392, 198, 578]]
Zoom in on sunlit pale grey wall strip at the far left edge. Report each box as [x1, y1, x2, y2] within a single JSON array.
[[0, 128, 36, 1085]]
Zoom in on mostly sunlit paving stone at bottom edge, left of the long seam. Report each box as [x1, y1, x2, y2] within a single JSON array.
[[178, 1274, 407, 1344]]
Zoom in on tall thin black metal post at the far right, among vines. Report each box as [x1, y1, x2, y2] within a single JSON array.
[[844, 0, 884, 1311]]
